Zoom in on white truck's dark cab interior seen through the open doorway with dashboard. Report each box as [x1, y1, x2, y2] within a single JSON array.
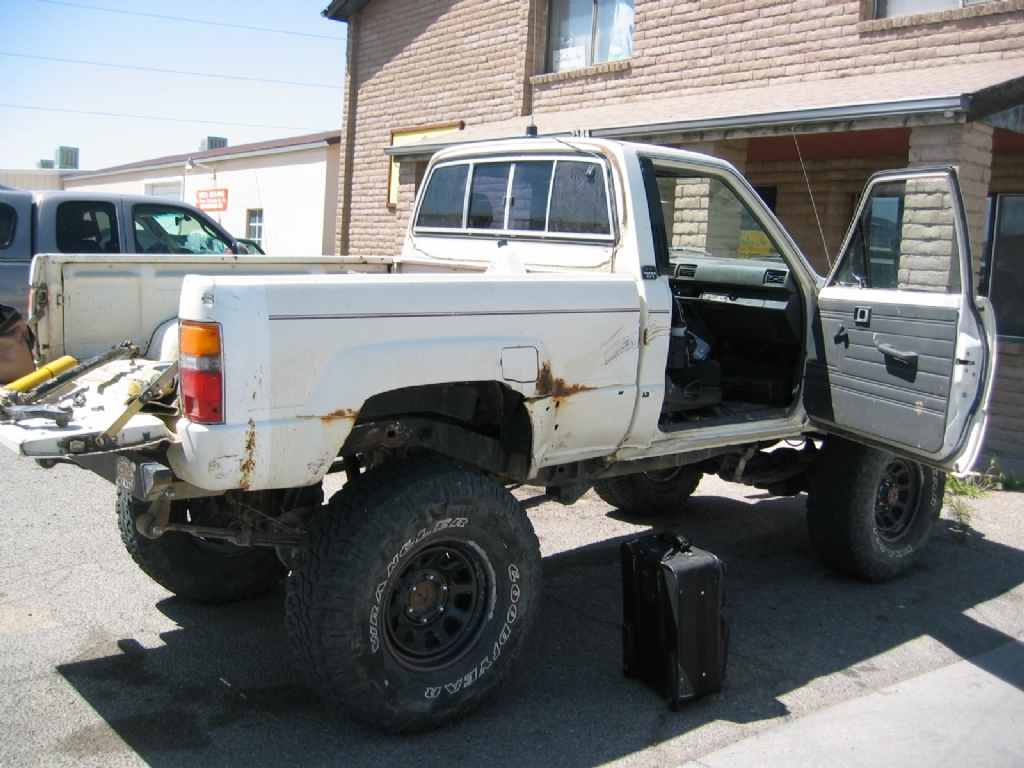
[[644, 160, 804, 431]]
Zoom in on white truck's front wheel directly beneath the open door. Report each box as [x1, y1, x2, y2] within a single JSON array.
[[807, 437, 946, 582]]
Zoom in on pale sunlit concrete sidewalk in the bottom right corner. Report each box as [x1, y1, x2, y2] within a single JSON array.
[[683, 640, 1024, 768]]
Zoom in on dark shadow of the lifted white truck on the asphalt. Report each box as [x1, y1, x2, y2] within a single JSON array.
[[58, 496, 1024, 767]]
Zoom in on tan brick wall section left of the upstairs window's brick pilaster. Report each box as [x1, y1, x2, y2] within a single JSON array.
[[339, 0, 536, 255]]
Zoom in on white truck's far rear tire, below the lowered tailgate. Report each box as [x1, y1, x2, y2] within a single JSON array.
[[118, 488, 288, 604]]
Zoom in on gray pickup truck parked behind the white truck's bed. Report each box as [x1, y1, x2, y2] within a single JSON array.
[[0, 184, 241, 316]]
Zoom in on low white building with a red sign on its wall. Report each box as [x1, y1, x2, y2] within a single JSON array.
[[63, 131, 341, 256]]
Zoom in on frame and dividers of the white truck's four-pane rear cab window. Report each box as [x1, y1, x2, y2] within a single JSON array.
[[413, 154, 618, 244]]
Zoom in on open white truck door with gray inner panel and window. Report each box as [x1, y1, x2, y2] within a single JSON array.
[[804, 168, 995, 472]]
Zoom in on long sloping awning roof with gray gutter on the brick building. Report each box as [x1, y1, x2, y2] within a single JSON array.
[[384, 58, 1024, 160]]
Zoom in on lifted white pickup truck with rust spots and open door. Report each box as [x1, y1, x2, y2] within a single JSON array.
[[0, 138, 995, 732]]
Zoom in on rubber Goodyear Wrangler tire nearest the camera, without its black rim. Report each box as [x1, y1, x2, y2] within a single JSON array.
[[286, 459, 542, 733]]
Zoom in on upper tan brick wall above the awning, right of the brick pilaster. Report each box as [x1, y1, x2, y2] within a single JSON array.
[[534, 0, 1024, 112]]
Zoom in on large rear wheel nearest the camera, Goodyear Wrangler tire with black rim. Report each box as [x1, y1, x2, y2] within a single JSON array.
[[286, 459, 541, 733]]
